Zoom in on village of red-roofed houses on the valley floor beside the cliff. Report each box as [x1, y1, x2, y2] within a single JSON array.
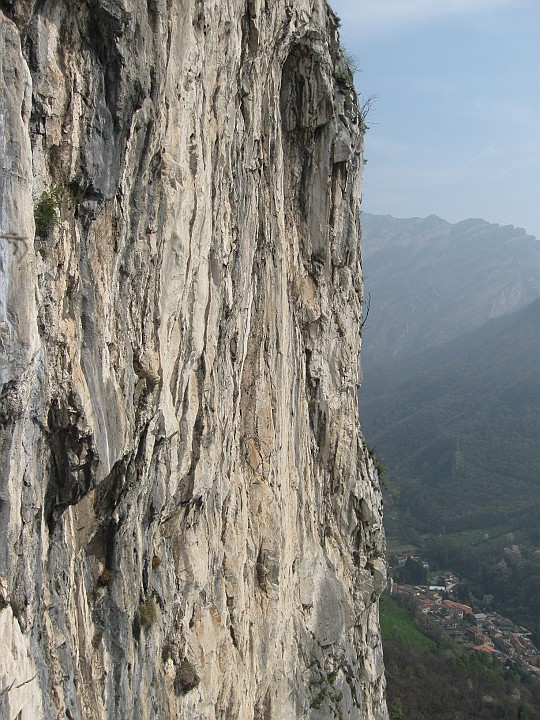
[[390, 573, 540, 678]]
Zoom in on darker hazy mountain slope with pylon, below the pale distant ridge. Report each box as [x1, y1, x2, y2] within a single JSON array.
[[360, 299, 540, 531]]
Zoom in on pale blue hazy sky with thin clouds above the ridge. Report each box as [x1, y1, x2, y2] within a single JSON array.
[[330, 0, 540, 239]]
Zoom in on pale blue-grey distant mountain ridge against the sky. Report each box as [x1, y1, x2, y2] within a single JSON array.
[[362, 213, 540, 369]]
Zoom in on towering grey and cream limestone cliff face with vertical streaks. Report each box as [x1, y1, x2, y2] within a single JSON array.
[[0, 0, 386, 720]]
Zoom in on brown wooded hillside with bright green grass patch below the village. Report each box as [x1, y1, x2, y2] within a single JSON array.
[[381, 596, 540, 720]]
